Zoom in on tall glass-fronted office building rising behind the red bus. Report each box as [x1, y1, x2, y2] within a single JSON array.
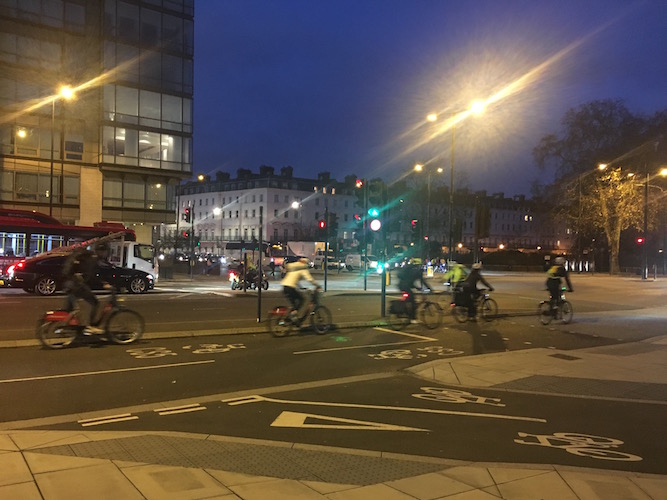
[[0, 0, 194, 229]]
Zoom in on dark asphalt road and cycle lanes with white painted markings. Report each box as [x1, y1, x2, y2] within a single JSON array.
[[0, 276, 667, 474]]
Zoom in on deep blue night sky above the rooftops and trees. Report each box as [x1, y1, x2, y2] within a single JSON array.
[[194, 0, 667, 196]]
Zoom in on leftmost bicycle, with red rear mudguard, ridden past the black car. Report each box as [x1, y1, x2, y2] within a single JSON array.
[[37, 287, 144, 349]]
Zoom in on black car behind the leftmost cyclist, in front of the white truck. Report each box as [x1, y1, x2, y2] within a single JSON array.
[[9, 254, 155, 295]]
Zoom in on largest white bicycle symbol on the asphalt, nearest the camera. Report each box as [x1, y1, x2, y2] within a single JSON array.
[[514, 432, 643, 462]]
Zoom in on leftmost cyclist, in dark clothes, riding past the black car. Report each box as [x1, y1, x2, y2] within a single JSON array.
[[63, 242, 110, 335]]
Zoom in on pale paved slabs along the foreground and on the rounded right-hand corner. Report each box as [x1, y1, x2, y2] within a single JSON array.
[[0, 274, 667, 500]]
